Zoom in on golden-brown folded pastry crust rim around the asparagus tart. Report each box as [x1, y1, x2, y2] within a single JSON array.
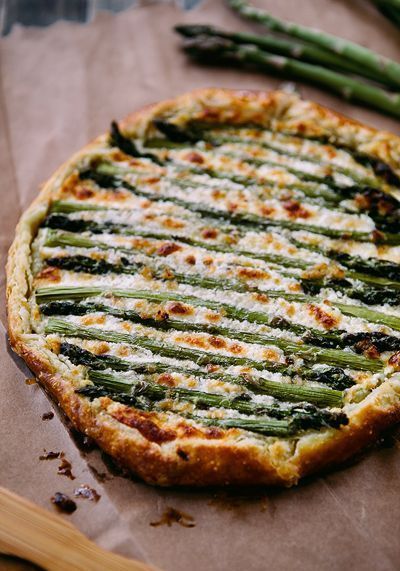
[[7, 89, 400, 486]]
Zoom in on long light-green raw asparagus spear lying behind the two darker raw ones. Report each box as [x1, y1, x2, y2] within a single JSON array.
[[228, 0, 400, 87]]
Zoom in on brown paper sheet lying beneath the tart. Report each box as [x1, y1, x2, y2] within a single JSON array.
[[0, 0, 400, 571]]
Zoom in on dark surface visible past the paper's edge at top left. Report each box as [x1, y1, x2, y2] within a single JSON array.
[[0, 0, 201, 36]]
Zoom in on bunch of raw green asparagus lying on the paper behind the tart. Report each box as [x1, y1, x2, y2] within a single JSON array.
[[175, 0, 400, 118]]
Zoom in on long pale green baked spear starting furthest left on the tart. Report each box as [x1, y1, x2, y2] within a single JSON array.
[[36, 286, 390, 358]]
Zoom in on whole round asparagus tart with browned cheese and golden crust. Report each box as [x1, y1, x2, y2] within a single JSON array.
[[8, 89, 400, 486]]
